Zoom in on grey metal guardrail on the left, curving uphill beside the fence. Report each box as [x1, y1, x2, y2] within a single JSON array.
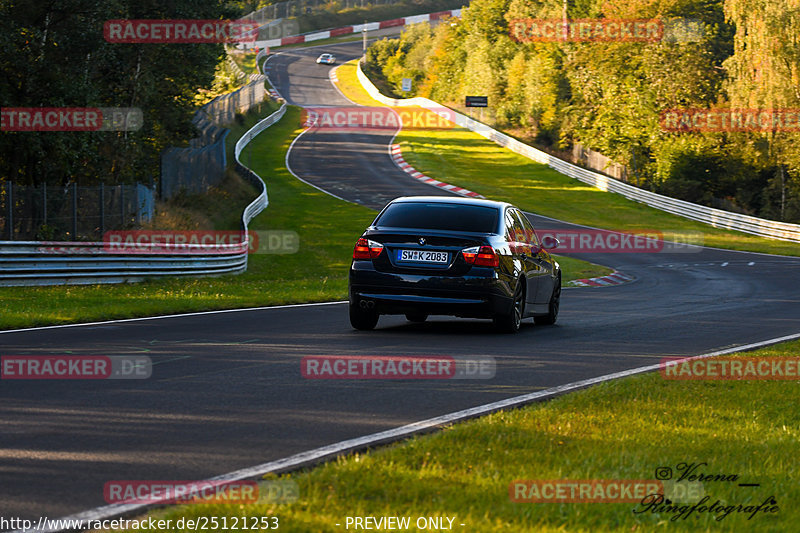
[[0, 104, 286, 286]]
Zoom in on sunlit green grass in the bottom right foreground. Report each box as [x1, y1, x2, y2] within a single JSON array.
[[114, 342, 800, 533]]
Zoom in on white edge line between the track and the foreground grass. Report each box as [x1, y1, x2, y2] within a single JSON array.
[[26, 333, 800, 533]]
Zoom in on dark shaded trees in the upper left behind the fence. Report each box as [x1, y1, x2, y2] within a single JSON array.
[[0, 0, 242, 186]]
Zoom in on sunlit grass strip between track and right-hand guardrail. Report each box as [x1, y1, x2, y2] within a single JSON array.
[[337, 61, 800, 255]]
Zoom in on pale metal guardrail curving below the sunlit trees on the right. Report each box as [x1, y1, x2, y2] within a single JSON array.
[[357, 63, 800, 242]]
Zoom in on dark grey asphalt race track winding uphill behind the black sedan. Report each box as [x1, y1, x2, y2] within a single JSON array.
[[0, 39, 800, 519]]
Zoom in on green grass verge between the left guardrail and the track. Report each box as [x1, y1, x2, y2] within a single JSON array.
[[0, 104, 608, 329]]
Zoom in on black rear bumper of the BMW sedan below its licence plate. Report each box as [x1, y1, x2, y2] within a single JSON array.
[[350, 268, 512, 318]]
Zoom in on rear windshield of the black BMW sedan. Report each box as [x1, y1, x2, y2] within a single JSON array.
[[375, 202, 498, 233]]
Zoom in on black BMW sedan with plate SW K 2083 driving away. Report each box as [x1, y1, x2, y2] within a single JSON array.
[[350, 196, 561, 333]]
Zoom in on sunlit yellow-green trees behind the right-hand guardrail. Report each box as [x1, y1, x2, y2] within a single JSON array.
[[367, 0, 800, 222]]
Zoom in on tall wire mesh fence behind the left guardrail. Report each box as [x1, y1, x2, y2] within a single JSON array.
[[0, 78, 268, 241]]
